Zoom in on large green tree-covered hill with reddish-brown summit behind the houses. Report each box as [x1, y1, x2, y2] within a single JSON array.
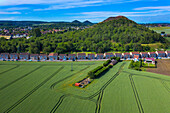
[[0, 16, 168, 53]]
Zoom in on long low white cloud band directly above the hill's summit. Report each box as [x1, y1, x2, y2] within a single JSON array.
[[68, 10, 170, 21]]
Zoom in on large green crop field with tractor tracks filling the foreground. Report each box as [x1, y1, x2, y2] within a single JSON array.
[[0, 61, 170, 113]]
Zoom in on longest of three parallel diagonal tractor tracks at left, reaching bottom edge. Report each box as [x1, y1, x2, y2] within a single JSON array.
[[4, 66, 64, 113]]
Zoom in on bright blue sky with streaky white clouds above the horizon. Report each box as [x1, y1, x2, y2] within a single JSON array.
[[0, 0, 170, 23]]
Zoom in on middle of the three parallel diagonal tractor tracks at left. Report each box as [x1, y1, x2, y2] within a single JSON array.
[[0, 65, 43, 91]]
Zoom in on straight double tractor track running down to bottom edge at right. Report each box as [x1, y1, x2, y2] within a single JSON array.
[[129, 75, 144, 113]]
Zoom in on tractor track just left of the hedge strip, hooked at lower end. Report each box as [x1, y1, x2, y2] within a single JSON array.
[[50, 66, 90, 89]]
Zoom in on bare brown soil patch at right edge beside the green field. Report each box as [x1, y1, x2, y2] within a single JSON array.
[[147, 60, 170, 76]]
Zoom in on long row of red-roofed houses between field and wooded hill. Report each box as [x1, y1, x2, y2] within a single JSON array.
[[0, 51, 170, 61]]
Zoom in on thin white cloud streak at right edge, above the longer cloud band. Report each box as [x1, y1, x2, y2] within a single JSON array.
[[134, 6, 170, 11]]
